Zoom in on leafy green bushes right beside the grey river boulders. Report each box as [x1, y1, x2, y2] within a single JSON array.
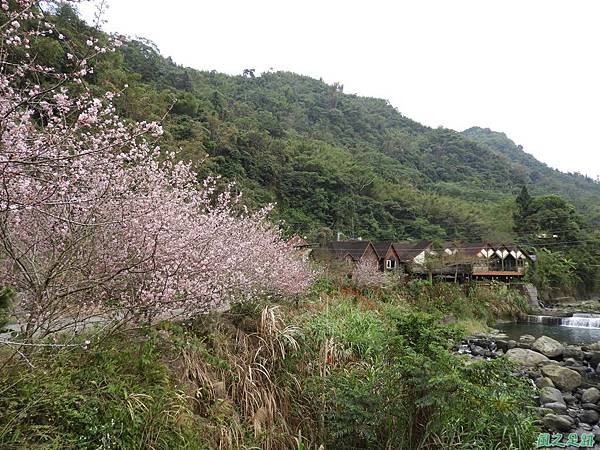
[[390, 313, 535, 448]]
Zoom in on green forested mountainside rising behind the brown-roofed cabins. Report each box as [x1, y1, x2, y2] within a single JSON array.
[[49, 4, 600, 240]]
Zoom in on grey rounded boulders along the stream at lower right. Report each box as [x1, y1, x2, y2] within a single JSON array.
[[454, 333, 600, 448]]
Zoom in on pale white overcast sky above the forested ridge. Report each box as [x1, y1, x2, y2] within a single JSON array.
[[81, 0, 600, 177]]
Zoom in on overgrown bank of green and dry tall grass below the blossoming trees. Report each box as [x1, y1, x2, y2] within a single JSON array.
[[0, 279, 536, 450]]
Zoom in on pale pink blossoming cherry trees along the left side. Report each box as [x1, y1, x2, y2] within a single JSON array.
[[0, 0, 312, 329]]
